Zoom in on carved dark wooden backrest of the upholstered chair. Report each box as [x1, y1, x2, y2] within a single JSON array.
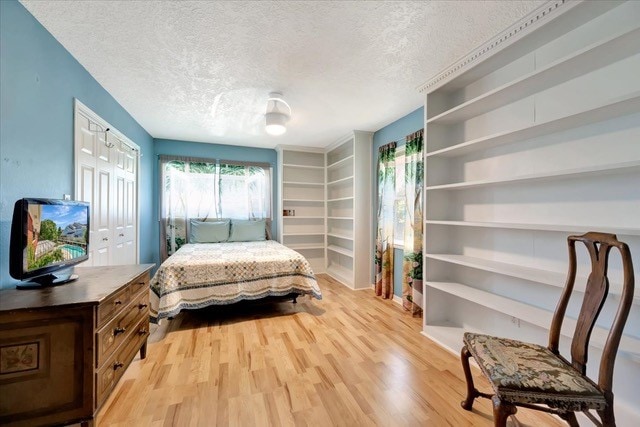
[[549, 232, 634, 391]]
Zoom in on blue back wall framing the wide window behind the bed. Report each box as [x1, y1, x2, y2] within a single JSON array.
[[153, 139, 279, 242]]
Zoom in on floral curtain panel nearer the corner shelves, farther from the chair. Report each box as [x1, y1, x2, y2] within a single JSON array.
[[375, 142, 396, 298]]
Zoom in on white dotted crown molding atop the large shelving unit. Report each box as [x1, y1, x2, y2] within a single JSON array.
[[418, 0, 572, 93]]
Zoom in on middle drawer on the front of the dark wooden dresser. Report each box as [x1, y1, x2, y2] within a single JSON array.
[[96, 292, 149, 368]]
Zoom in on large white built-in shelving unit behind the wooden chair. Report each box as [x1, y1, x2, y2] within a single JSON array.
[[421, 0, 640, 425]]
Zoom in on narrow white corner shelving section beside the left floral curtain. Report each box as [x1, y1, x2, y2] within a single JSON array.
[[326, 131, 373, 289]]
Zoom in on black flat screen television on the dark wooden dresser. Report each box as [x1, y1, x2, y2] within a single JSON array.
[[9, 198, 90, 289]]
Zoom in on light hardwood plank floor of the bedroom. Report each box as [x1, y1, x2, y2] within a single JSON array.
[[97, 275, 563, 427]]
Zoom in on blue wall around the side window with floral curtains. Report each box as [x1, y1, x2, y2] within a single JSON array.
[[371, 107, 424, 296]]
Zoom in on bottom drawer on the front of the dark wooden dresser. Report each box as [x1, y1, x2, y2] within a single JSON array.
[[96, 317, 149, 407]]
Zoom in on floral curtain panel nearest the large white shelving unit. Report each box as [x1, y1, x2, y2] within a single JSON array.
[[402, 130, 424, 316]]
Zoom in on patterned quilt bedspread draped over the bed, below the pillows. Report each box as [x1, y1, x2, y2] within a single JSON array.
[[150, 240, 322, 323]]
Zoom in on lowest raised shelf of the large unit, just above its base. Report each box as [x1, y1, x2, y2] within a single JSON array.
[[426, 282, 640, 355]]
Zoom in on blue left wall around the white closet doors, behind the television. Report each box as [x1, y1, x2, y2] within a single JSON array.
[[0, 1, 158, 287]]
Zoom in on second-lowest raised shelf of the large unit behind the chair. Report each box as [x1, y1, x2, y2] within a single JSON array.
[[425, 254, 640, 304]]
